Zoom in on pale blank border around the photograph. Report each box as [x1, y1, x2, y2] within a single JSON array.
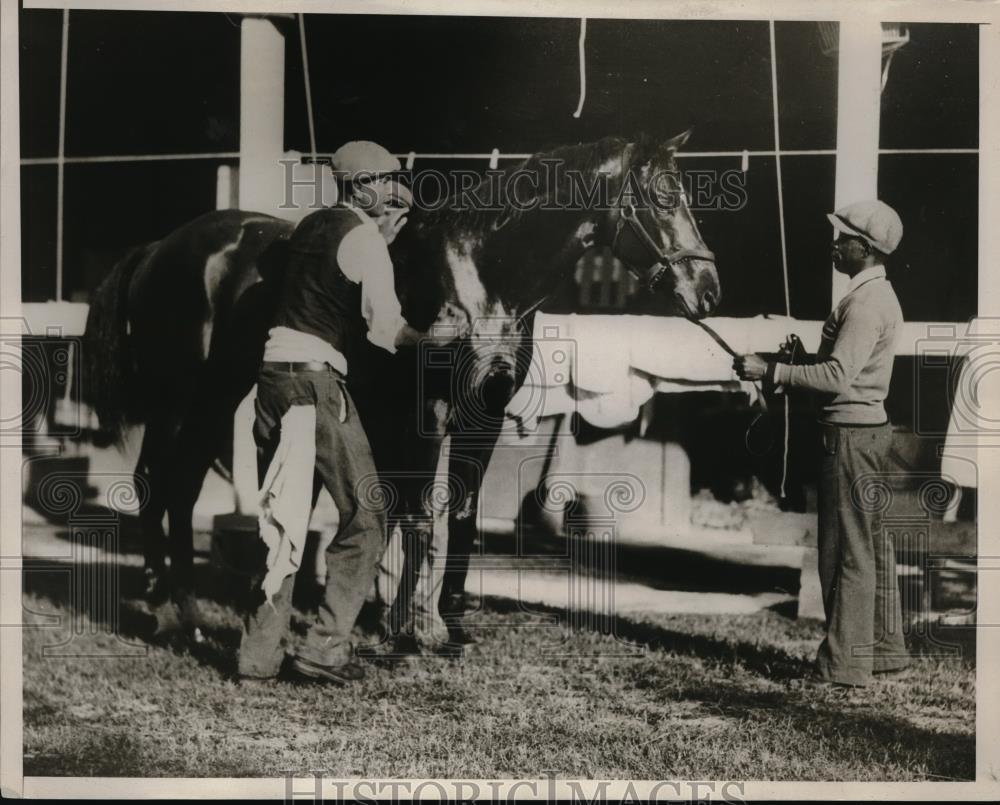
[[0, 0, 1000, 801]]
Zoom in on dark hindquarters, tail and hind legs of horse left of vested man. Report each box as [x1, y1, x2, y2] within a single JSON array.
[[79, 210, 295, 622]]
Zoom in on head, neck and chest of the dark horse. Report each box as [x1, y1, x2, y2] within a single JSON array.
[[391, 132, 721, 415]]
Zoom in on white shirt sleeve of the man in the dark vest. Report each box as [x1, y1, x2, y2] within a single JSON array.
[[337, 225, 406, 352]]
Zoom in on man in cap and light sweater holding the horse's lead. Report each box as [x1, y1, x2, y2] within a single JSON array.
[[734, 201, 909, 686]]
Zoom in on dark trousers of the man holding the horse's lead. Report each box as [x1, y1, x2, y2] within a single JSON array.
[[816, 424, 909, 685]]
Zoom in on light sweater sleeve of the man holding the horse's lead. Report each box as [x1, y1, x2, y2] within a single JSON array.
[[768, 302, 882, 394]]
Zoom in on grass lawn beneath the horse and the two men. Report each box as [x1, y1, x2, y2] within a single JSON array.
[[17, 552, 975, 781]]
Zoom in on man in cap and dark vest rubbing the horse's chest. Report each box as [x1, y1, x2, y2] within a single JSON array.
[[239, 142, 422, 684]]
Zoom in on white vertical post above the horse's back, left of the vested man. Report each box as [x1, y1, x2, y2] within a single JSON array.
[[239, 17, 285, 212]]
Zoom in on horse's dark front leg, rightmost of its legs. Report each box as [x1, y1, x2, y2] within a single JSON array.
[[438, 421, 500, 642]]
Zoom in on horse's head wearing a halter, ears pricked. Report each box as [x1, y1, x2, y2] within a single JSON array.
[[602, 131, 721, 319]]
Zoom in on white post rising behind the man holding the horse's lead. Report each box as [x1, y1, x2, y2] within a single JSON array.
[[833, 19, 882, 305]]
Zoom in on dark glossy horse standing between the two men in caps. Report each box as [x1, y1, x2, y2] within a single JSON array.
[[83, 132, 721, 636]]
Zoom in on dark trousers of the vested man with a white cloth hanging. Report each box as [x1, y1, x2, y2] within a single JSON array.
[[239, 365, 386, 677]]
